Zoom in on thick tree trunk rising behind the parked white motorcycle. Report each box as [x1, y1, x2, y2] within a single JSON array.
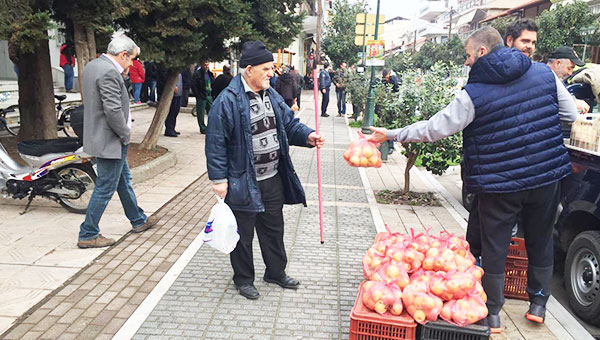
[[11, 40, 57, 141]]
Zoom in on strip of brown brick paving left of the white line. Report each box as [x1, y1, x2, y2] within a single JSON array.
[[0, 176, 216, 339]]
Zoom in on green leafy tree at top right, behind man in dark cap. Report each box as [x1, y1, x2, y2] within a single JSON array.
[[536, 1, 600, 55]]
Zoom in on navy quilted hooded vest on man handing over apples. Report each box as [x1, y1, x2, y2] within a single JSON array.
[[463, 47, 571, 193]]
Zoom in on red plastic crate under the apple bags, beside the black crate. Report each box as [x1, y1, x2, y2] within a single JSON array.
[[350, 282, 417, 340]]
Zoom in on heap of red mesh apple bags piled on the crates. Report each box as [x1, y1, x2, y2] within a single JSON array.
[[362, 225, 488, 326]]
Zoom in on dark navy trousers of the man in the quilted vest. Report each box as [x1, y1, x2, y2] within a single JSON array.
[[478, 182, 559, 314]]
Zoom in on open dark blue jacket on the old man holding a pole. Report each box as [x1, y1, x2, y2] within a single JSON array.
[[205, 75, 314, 212]]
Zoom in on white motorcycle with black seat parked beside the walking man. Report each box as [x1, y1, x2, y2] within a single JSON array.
[[0, 105, 96, 214]]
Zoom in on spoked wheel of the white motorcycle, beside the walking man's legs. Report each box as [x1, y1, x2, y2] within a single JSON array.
[[56, 163, 96, 214]]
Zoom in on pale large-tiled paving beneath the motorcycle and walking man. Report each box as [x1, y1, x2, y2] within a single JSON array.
[[0, 103, 206, 334]]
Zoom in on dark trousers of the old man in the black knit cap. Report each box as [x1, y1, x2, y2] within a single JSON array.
[[229, 175, 287, 286]]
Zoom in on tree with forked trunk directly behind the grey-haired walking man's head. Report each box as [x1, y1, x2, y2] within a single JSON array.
[[52, 0, 119, 97]]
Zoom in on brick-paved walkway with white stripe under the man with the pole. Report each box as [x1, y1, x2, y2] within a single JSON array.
[[0, 93, 579, 340]]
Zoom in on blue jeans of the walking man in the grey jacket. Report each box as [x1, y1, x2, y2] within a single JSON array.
[[79, 145, 148, 241]]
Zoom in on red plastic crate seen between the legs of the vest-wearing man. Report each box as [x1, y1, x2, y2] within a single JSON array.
[[504, 237, 529, 300]]
